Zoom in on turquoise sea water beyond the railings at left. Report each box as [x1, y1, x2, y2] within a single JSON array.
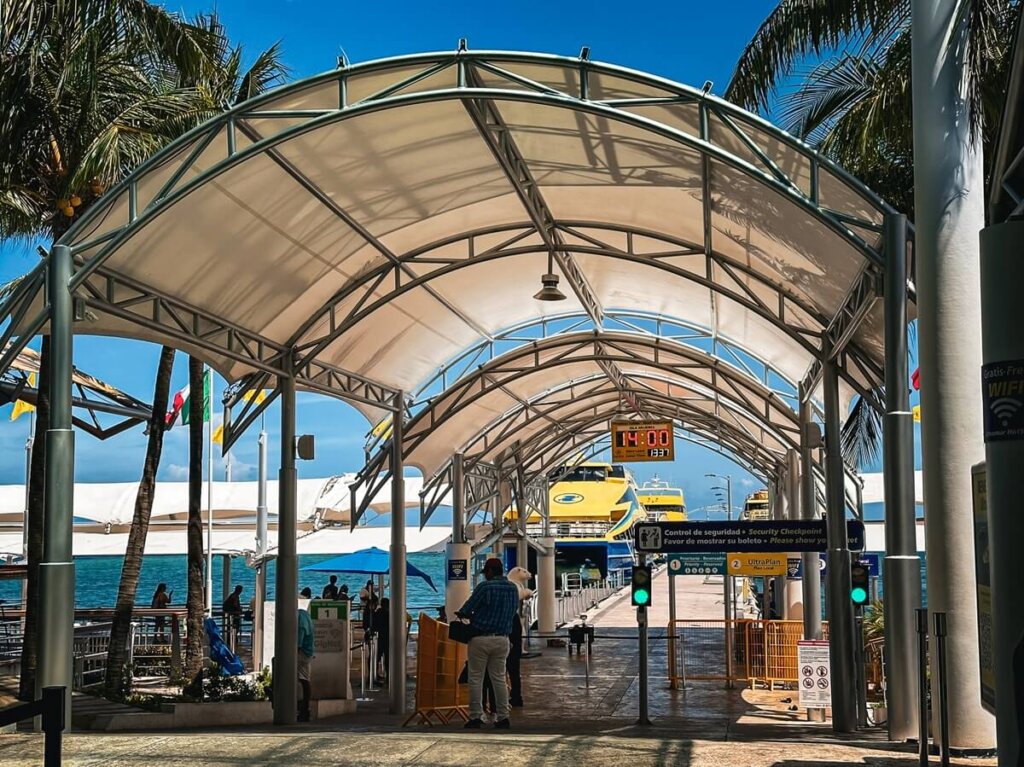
[[0, 552, 444, 611]]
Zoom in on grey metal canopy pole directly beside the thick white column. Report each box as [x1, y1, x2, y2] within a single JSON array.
[[883, 213, 921, 740]]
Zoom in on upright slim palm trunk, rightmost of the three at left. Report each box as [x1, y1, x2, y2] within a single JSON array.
[[185, 355, 205, 690]]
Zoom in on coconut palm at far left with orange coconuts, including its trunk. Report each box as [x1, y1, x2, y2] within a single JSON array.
[[0, 0, 276, 697]]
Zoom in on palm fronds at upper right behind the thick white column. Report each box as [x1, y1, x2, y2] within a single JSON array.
[[726, 0, 1022, 465]]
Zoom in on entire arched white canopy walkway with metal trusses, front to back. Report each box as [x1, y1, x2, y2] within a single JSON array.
[[0, 49, 912, 729]]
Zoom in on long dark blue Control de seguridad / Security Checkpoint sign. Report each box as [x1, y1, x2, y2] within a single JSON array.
[[635, 519, 864, 552]]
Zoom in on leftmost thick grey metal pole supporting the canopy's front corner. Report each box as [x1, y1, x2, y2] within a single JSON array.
[[36, 245, 75, 723]]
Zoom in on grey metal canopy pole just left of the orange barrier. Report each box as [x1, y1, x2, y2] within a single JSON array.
[[388, 395, 406, 715]]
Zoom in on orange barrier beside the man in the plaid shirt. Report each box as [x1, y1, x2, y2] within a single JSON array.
[[402, 612, 469, 727]]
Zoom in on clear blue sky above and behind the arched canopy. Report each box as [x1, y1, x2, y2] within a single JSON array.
[[0, 0, 925, 508]]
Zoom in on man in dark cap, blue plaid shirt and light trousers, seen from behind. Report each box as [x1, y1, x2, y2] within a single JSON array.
[[456, 557, 519, 730]]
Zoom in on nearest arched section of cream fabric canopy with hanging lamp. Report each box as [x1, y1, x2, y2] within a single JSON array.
[[51, 51, 885, 434]]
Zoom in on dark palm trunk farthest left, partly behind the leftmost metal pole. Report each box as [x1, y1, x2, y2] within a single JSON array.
[[18, 336, 50, 700]]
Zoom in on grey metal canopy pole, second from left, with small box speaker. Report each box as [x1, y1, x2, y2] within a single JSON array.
[[273, 375, 299, 724]]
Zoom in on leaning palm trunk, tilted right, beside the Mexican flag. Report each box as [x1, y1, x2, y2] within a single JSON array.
[[104, 346, 174, 697]]
